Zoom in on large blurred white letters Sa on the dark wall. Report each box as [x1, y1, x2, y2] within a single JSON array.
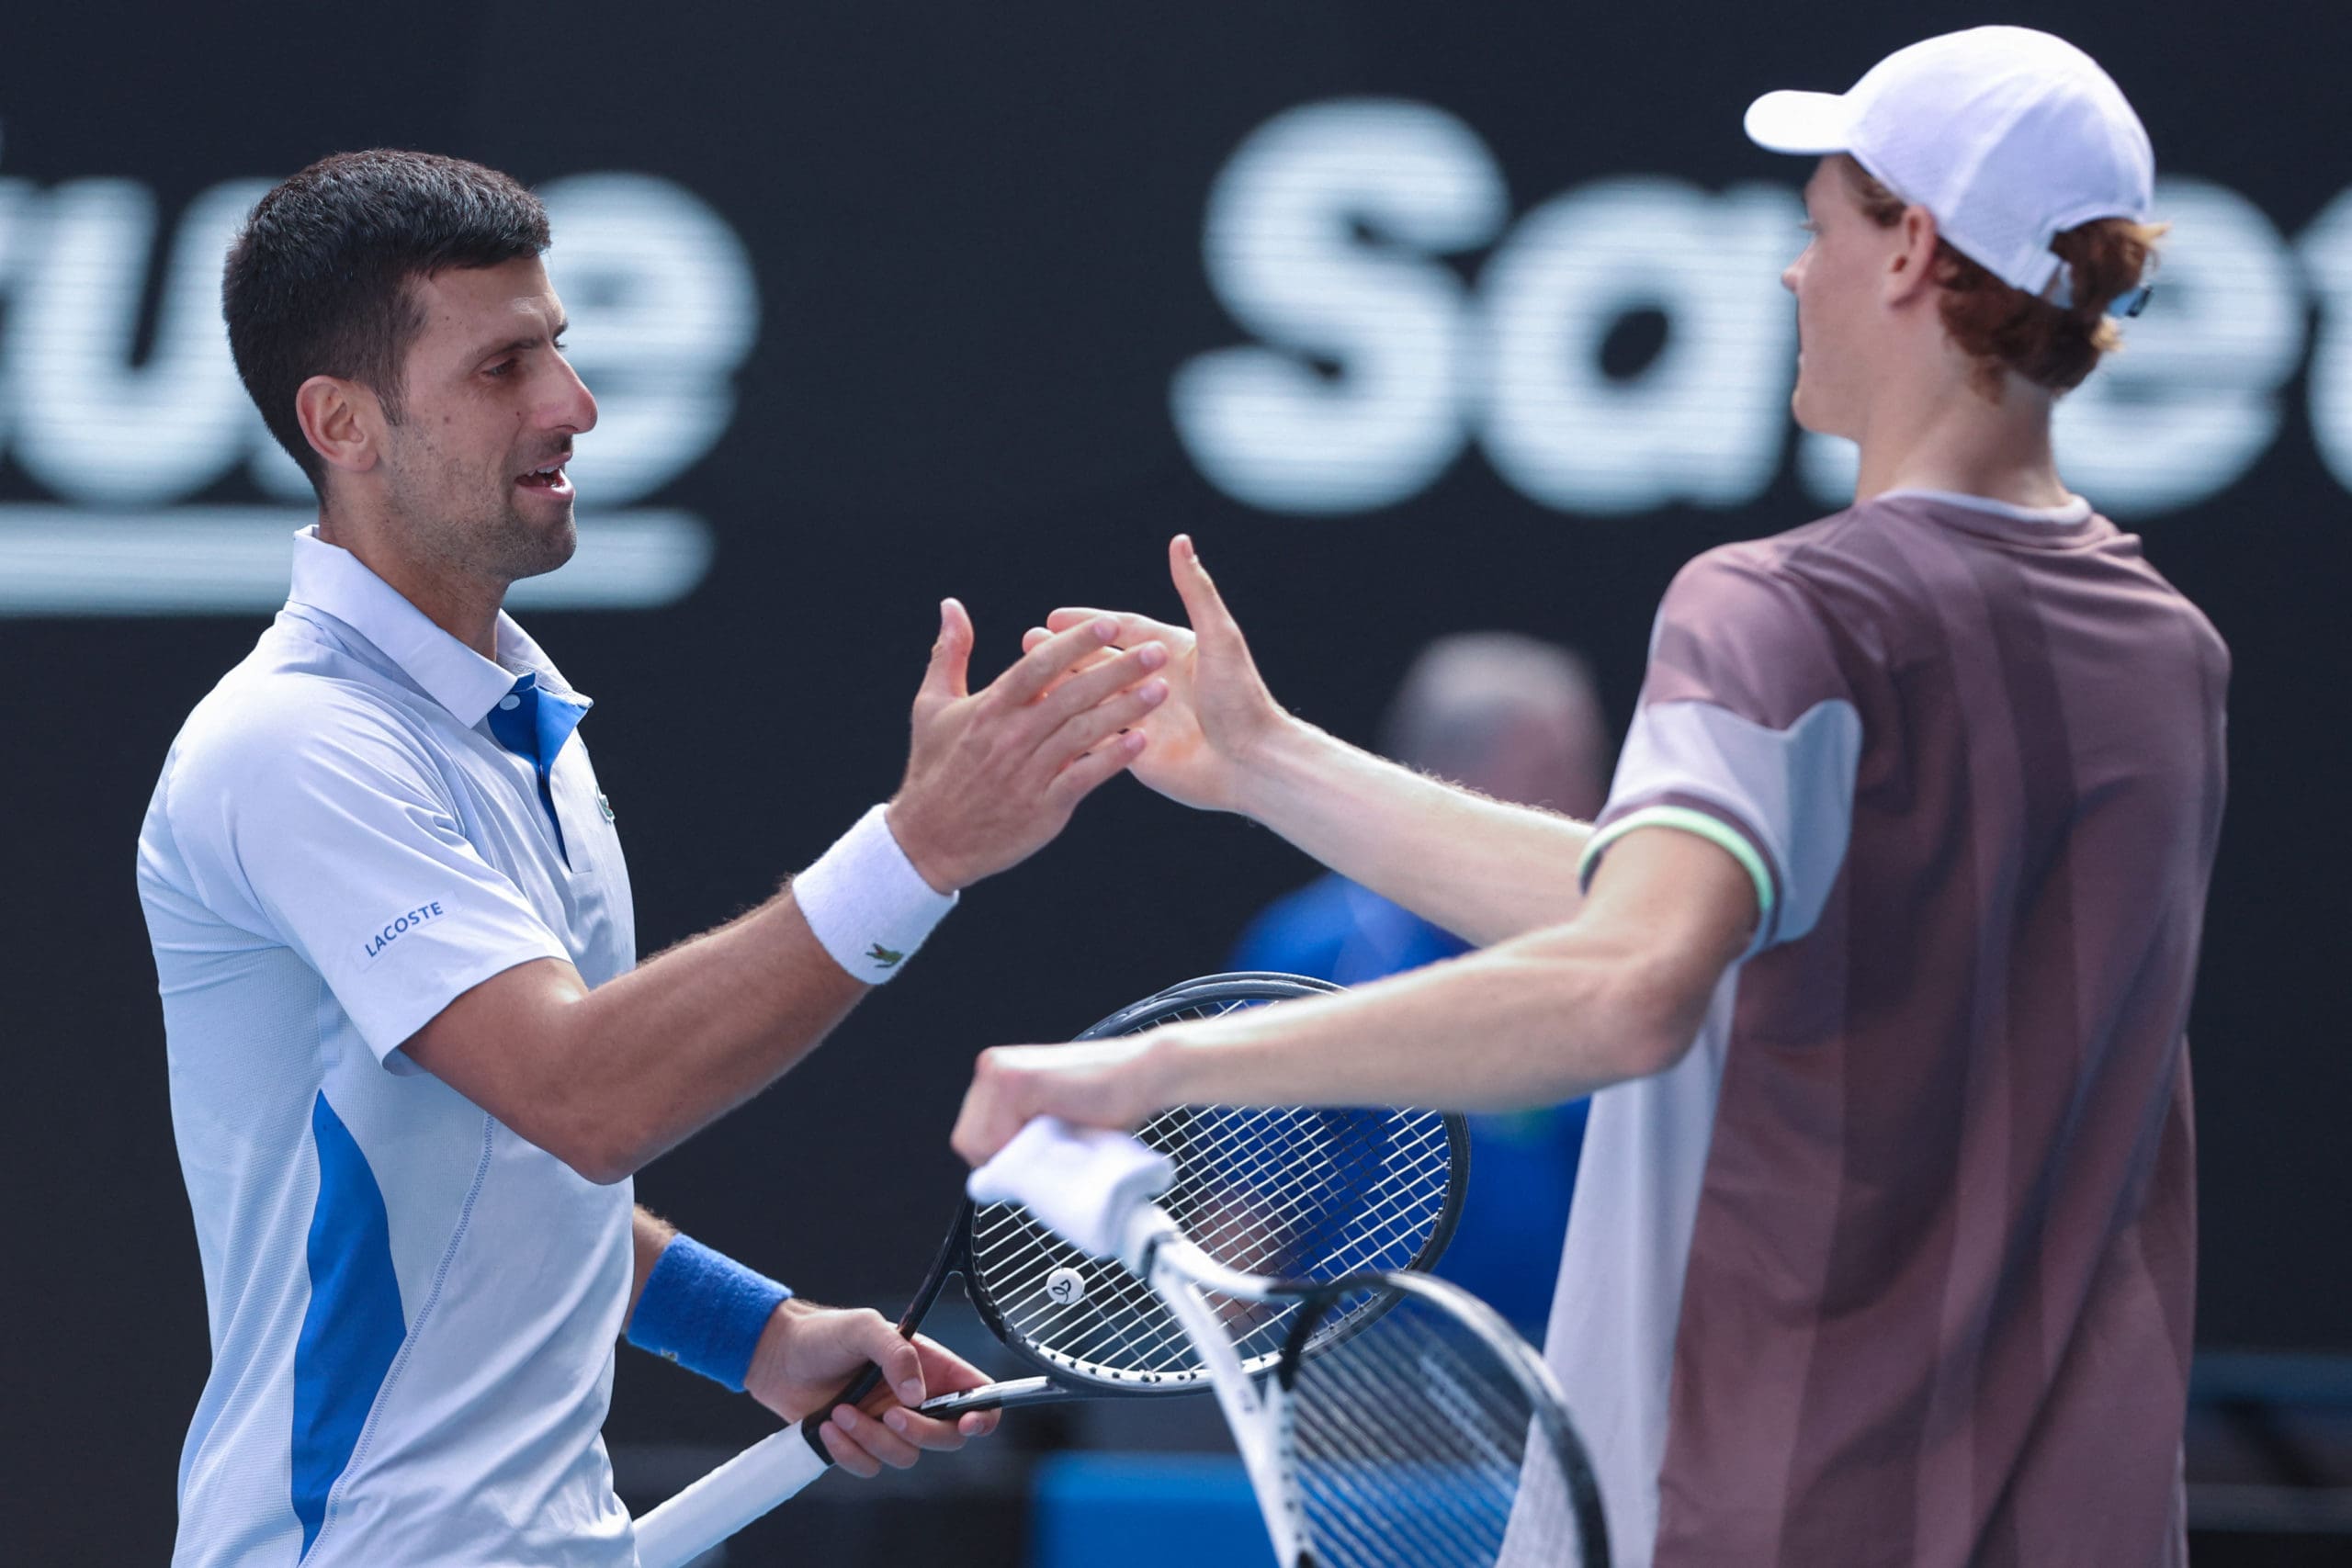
[[1173, 101, 1804, 513]]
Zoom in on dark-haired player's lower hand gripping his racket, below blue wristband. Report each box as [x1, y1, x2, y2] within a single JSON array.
[[743, 1300, 997, 1476]]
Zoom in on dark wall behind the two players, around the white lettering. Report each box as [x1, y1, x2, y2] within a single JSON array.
[[0, 0, 2352, 1563]]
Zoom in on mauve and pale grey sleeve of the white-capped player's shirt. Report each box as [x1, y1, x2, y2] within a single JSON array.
[[1580, 547, 1863, 954]]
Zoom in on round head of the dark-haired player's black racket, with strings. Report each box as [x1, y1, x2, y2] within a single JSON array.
[[965, 974, 1470, 1394]]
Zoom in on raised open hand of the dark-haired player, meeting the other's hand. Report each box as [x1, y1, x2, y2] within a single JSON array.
[[887, 600, 1169, 894]]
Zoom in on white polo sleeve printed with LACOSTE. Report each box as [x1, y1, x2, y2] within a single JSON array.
[[169, 682, 571, 1063]]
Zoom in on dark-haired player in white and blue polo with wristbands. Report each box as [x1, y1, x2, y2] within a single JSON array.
[[139, 152, 1164, 1568]]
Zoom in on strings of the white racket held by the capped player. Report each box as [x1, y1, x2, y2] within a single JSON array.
[[1289, 1298, 1576, 1568]]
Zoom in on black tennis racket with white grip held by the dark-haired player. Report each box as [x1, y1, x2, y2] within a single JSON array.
[[638, 974, 1470, 1568]]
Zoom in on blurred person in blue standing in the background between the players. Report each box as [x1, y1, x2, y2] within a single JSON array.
[[1232, 632, 1611, 1340]]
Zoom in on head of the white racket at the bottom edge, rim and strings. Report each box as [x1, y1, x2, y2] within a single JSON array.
[[1261, 1272, 1609, 1568]]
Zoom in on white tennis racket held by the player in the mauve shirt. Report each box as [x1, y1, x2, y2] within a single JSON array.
[[971, 1119, 1609, 1568]]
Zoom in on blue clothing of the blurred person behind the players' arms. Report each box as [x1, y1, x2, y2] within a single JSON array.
[[1232, 874, 1585, 1340]]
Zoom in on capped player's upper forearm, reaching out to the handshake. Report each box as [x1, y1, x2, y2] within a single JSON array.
[[1242, 719, 1592, 945]]
